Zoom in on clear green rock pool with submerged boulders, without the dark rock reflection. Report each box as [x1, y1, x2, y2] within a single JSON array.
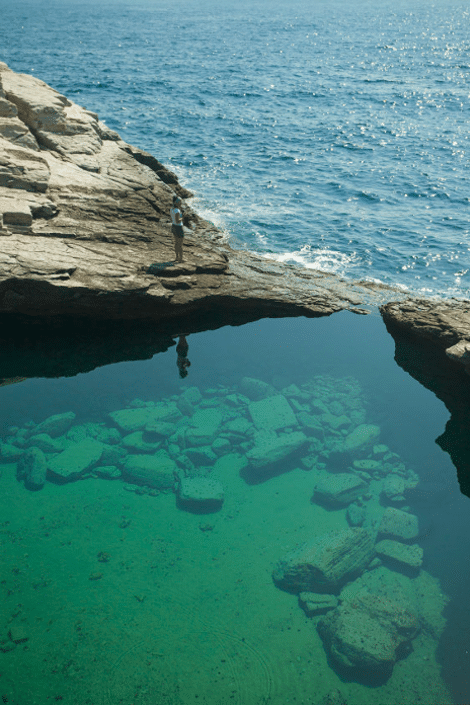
[[0, 312, 470, 705]]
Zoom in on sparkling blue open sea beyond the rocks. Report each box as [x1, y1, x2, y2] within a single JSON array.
[[0, 0, 470, 298]]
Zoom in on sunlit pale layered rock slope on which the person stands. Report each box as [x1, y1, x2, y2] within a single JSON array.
[[0, 63, 400, 320]]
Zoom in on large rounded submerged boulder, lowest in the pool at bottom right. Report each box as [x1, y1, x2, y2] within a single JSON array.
[[317, 593, 419, 679]]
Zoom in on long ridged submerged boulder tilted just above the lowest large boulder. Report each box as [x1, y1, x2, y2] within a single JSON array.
[[273, 528, 374, 593]]
